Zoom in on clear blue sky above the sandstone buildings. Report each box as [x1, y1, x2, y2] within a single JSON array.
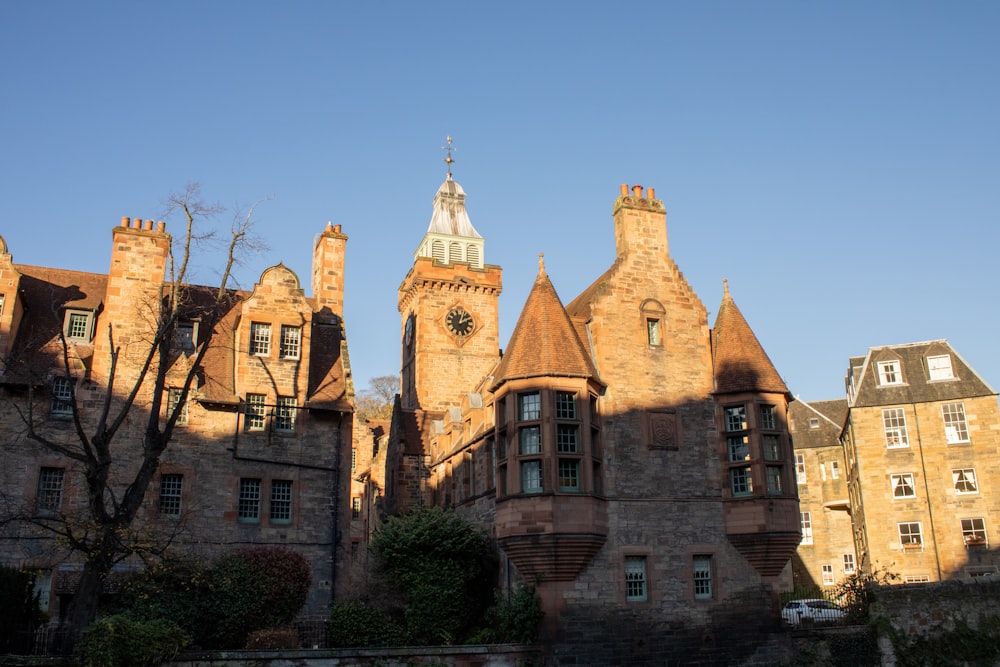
[[0, 0, 1000, 400]]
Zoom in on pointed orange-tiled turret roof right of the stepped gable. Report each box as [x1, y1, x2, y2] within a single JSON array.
[[712, 279, 789, 394]]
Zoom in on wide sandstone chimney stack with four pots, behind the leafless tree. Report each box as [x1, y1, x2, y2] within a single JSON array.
[[93, 217, 170, 381]]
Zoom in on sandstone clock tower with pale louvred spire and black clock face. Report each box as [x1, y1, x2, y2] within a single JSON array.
[[399, 154, 502, 412]]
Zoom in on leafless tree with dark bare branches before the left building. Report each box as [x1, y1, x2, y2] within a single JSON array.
[[1, 184, 263, 628]]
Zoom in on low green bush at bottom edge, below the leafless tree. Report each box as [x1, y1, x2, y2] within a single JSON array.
[[77, 614, 189, 667]]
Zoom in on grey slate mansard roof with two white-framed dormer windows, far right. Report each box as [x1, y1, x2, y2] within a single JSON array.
[[847, 339, 997, 407]]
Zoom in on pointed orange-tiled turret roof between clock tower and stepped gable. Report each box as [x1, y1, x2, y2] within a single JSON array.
[[493, 254, 603, 390]]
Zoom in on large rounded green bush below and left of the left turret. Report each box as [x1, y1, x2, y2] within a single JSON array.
[[371, 508, 495, 645]]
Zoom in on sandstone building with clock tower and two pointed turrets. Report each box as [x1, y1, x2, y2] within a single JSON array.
[[353, 173, 800, 664]]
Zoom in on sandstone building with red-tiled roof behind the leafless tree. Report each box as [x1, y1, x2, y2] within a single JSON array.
[[0, 218, 352, 617]]
